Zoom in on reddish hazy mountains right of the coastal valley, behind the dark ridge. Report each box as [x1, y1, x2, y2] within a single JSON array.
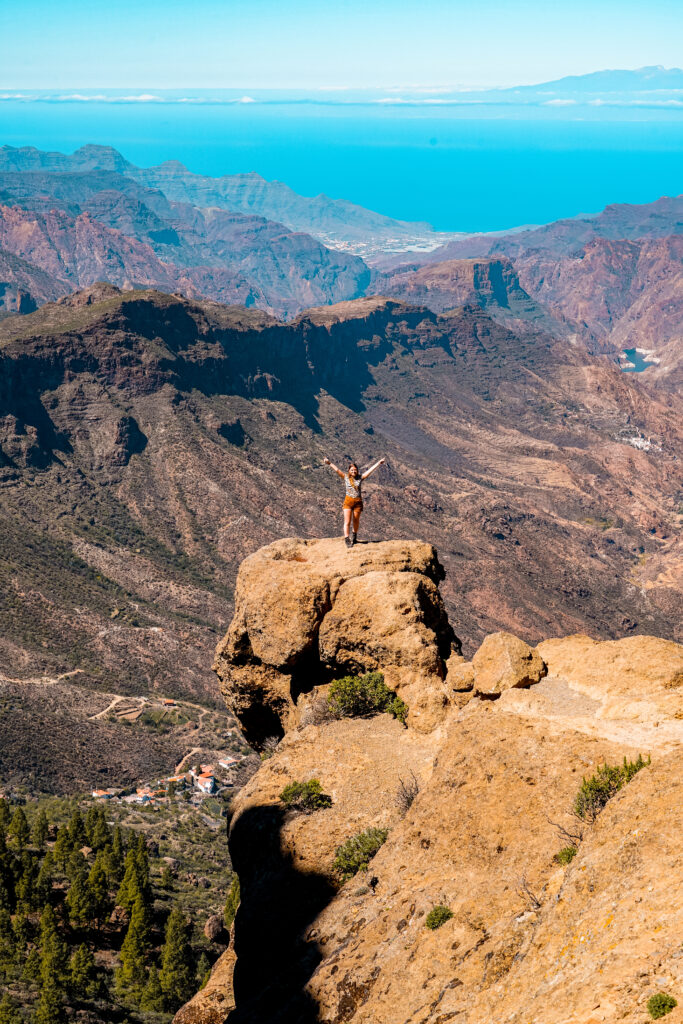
[[372, 196, 683, 387]]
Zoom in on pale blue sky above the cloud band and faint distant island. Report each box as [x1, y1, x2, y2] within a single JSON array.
[[0, 0, 683, 89]]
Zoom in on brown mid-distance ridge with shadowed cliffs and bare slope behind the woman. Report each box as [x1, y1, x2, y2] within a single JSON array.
[[0, 285, 683, 794]]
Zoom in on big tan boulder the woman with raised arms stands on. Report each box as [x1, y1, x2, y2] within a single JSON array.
[[215, 539, 460, 744]]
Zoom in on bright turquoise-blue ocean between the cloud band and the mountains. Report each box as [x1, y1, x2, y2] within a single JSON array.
[[0, 98, 683, 231]]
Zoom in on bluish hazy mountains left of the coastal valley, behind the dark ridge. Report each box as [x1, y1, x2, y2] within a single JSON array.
[[0, 145, 453, 317]]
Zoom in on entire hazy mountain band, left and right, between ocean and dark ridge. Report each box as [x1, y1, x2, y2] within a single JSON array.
[[0, 144, 683, 386]]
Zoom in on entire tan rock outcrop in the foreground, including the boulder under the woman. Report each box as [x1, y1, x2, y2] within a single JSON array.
[[181, 540, 683, 1024]]
